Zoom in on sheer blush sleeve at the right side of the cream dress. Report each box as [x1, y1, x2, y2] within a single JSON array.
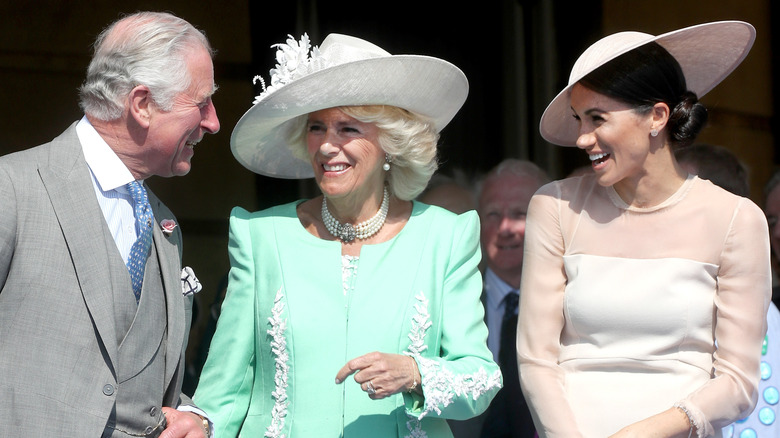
[[681, 199, 772, 436]]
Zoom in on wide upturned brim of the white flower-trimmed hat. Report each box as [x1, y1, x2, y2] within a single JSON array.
[[230, 55, 468, 179]]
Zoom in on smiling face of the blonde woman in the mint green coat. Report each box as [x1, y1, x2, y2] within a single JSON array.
[[306, 108, 385, 204]]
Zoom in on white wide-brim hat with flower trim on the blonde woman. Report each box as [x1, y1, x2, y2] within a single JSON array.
[[230, 34, 468, 179]]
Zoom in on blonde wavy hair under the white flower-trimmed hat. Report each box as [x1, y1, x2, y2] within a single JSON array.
[[287, 105, 439, 201]]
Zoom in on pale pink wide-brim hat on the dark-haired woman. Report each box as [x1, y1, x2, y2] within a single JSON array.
[[539, 21, 756, 146]]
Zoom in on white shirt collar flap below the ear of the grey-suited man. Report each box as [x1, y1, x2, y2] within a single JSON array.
[[76, 116, 135, 192]]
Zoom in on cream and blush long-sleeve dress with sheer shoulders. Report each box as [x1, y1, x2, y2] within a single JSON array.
[[517, 175, 771, 438]]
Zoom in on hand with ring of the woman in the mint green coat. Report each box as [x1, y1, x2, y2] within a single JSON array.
[[336, 351, 422, 400]]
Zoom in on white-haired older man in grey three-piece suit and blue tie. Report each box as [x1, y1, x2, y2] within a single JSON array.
[[0, 13, 219, 438]]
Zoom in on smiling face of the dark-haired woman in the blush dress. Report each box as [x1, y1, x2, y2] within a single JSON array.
[[571, 84, 652, 192]]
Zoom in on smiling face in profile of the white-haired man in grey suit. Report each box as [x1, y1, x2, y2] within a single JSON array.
[[144, 47, 219, 177]]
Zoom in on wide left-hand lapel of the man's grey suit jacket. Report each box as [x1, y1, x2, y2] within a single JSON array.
[[38, 124, 117, 363]]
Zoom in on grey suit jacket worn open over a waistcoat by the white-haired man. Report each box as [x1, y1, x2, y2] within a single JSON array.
[[0, 124, 192, 437]]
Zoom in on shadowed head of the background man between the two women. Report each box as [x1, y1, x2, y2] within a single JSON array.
[[479, 172, 540, 287]]
